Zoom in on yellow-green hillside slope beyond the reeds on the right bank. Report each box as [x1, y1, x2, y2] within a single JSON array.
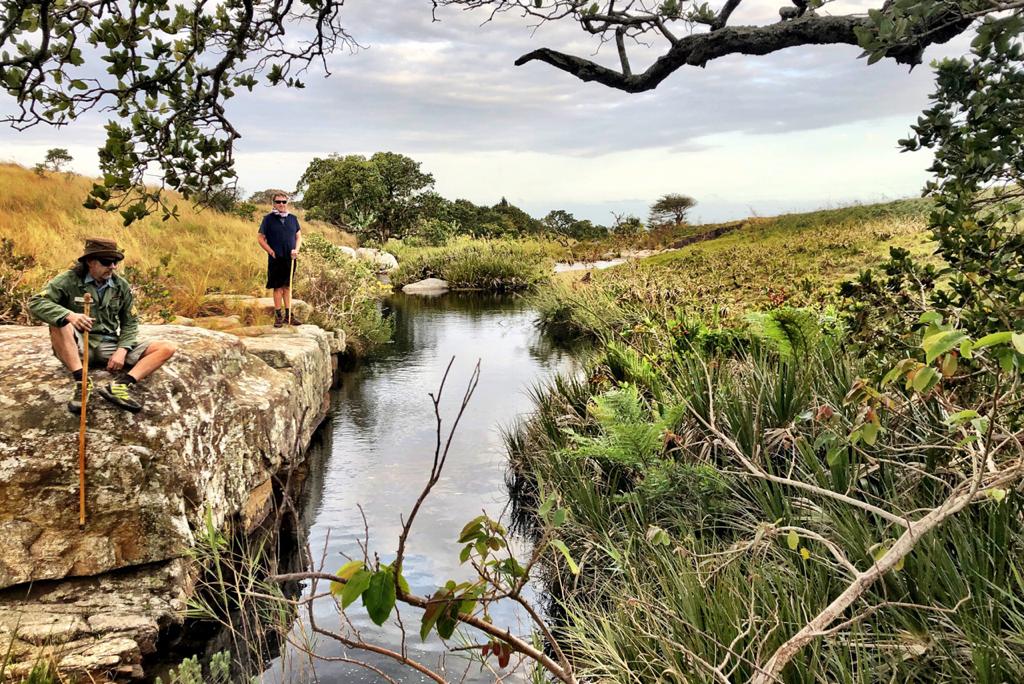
[[538, 200, 932, 334]]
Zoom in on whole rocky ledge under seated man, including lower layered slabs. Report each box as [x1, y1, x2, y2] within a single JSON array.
[[0, 326, 344, 678]]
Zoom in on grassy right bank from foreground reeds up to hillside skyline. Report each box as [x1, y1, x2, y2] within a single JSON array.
[[507, 201, 1024, 684]]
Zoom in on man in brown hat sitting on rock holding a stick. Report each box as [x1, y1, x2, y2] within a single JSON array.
[[29, 238, 177, 413]]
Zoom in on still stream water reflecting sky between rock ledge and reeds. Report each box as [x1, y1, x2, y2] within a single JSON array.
[[265, 293, 573, 683]]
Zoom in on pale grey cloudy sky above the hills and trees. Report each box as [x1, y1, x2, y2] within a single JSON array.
[[0, 0, 966, 223]]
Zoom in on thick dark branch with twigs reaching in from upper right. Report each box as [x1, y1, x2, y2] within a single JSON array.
[[433, 0, 987, 92]]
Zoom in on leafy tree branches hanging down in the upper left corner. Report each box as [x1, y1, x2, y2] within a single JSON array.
[[0, 0, 356, 223]]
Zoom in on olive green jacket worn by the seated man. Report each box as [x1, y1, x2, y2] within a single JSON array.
[[29, 270, 138, 349]]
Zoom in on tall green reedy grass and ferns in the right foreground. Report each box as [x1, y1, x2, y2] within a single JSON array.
[[508, 336, 1024, 684]]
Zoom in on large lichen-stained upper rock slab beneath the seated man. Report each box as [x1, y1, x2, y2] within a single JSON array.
[[0, 326, 332, 588]]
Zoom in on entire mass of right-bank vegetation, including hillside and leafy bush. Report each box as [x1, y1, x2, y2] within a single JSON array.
[[508, 21, 1024, 684]]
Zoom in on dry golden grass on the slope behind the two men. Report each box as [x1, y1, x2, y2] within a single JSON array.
[[0, 164, 355, 315]]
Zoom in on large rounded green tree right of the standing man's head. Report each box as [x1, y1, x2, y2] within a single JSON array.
[[298, 152, 434, 243]]
